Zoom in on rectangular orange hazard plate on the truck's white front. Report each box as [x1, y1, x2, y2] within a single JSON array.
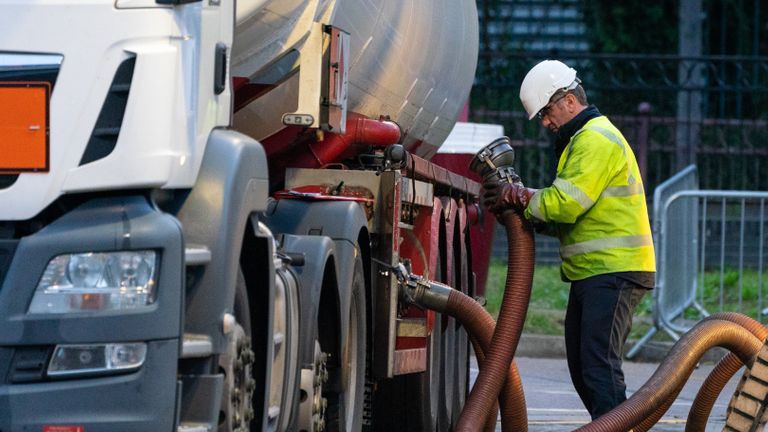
[[0, 82, 51, 174]]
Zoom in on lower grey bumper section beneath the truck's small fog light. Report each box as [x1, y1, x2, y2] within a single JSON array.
[[0, 340, 179, 432]]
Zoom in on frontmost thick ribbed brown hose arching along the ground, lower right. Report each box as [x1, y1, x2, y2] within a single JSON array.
[[577, 319, 762, 432]]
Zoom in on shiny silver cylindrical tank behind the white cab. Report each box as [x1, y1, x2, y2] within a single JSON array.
[[232, 0, 478, 158]]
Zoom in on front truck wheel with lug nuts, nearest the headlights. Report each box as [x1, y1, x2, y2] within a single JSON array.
[[219, 271, 256, 432]]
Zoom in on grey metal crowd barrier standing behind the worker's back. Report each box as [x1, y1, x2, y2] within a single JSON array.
[[627, 166, 768, 358]]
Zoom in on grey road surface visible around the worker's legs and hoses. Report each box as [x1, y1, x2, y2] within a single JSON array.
[[471, 357, 741, 432]]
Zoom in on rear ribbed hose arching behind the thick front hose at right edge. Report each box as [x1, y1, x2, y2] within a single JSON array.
[[685, 313, 768, 432]]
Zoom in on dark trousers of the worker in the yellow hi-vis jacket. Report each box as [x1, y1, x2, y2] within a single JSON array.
[[565, 274, 647, 419]]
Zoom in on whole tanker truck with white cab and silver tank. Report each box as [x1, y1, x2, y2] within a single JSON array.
[[0, 0, 493, 432]]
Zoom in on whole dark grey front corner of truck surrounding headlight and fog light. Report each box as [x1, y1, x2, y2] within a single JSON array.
[[0, 196, 184, 432]]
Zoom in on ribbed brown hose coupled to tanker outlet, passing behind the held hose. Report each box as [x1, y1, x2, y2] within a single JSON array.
[[444, 290, 528, 432]]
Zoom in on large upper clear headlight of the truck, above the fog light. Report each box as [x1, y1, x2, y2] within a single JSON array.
[[29, 250, 157, 313]]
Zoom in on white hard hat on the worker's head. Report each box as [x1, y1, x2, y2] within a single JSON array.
[[520, 60, 581, 120]]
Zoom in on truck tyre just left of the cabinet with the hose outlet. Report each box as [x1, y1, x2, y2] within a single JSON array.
[[328, 256, 367, 432]]
